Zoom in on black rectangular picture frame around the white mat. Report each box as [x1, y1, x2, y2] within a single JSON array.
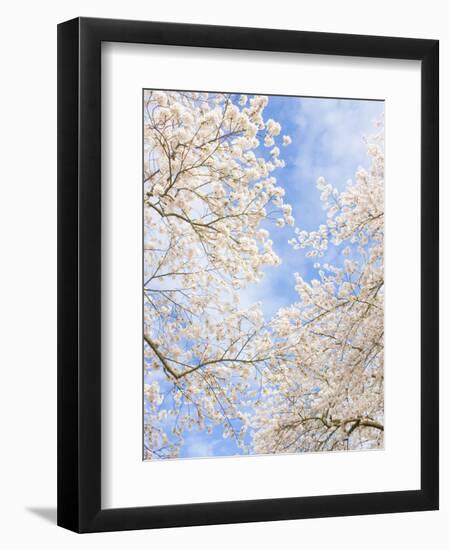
[[58, 18, 439, 533]]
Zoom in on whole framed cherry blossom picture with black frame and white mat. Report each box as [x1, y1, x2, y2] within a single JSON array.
[[58, 18, 439, 532]]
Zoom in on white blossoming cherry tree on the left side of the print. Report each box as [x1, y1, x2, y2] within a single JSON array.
[[143, 91, 294, 459]]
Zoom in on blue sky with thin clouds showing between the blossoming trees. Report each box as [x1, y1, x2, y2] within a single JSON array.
[[147, 91, 384, 458]]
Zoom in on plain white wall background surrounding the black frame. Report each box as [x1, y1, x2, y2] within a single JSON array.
[[0, 0, 450, 550]]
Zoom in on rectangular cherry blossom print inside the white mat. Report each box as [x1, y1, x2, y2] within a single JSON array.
[[142, 89, 384, 460]]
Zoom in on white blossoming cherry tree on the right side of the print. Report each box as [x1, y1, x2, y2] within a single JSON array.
[[253, 128, 384, 453]]
